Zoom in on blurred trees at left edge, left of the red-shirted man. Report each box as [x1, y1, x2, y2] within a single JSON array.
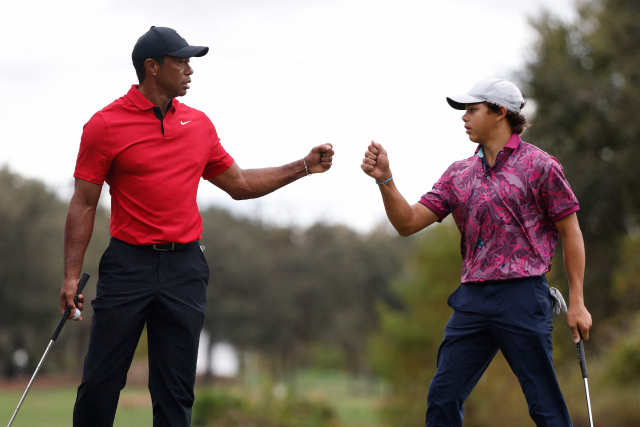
[[0, 167, 109, 370]]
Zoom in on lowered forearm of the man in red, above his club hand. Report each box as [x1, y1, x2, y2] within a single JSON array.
[[64, 198, 96, 280]]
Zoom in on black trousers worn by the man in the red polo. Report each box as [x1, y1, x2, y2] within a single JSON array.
[[73, 238, 209, 427]]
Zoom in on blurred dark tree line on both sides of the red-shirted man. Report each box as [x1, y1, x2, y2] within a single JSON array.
[[0, 168, 408, 375]]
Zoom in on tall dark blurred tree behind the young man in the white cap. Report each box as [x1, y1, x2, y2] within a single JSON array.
[[523, 0, 640, 333]]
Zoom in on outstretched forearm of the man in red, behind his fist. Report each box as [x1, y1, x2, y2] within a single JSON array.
[[231, 160, 307, 200]]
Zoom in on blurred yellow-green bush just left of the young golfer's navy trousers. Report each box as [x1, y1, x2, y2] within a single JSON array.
[[370, 219, 461, 427]]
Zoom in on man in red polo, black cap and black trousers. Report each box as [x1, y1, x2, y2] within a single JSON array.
[[60, 27, 334, 427]]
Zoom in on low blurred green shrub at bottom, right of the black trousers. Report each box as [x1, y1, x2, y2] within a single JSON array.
[[193, 391, 339, 427]]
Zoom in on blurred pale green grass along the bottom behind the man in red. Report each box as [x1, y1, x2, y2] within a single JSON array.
[[0, 371, 382, 427]]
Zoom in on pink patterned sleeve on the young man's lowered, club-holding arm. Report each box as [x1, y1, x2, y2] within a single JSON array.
[[538, 157, 580, 222]]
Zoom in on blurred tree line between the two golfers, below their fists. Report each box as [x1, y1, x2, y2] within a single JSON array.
[[202, 209, 407, 371]]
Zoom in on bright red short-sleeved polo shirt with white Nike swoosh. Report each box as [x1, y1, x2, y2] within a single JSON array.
[[74, 85, 233, 245]]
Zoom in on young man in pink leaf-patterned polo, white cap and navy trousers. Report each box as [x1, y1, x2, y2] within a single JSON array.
[[361, 78, 592, 427]]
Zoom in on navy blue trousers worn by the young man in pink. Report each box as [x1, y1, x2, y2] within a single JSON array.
[[426, 276, 571, 427]]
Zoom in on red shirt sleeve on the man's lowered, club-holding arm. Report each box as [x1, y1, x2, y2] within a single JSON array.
[[73, 113, 113, 185]]
